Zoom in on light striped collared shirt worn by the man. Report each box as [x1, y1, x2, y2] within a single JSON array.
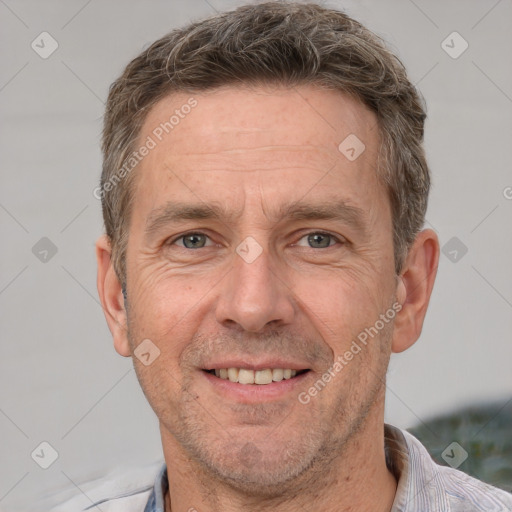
[[52, 425, 512, 512]]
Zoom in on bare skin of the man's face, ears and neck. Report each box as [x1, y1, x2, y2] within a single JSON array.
[[96, 86, 439, 512]]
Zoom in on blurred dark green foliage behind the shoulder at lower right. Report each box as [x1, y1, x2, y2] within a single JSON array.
[[407, 400, 512, 492]]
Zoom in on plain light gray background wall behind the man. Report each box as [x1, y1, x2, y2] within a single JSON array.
[[0, 0, 512, 511]]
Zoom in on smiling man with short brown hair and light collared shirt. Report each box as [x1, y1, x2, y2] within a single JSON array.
[[56, 3, 512, 512]]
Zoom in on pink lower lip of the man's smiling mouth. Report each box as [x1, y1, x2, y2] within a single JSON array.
[[201, 370, 312, 403]]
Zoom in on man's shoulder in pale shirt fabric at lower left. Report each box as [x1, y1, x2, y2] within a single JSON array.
[[45, 462, 162, 512]]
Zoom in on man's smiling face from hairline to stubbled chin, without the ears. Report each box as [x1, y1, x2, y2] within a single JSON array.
[[122, 87, 397, 490]]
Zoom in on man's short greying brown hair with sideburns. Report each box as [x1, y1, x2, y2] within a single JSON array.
[[100, 2, 430, 283]]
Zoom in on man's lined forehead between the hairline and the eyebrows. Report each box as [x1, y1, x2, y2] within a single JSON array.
[[130, 86, 382, 225]]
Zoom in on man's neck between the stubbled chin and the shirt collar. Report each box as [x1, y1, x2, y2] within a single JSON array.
[[161, 406, 397, 512]]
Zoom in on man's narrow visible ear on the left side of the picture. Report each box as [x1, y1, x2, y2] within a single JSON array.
[[96, 235, 131, 357]]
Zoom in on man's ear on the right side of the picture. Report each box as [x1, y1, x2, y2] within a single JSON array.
[[391, 229, 439, 352]]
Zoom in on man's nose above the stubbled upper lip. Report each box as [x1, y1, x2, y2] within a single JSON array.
[[215, 243, 295, 333]]
